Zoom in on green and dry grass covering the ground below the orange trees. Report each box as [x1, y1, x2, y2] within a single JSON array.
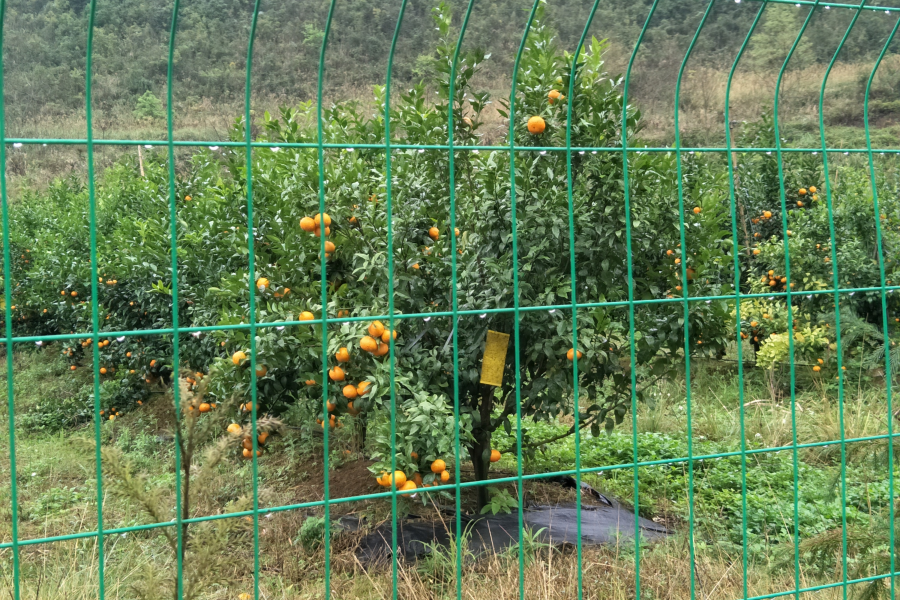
[[0, 350, 889, 599]]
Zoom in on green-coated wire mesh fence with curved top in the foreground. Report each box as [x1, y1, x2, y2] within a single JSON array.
[[0, 0, 900, 600]]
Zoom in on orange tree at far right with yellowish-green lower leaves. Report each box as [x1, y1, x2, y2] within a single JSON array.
[[737, 116, 900, 373]]
